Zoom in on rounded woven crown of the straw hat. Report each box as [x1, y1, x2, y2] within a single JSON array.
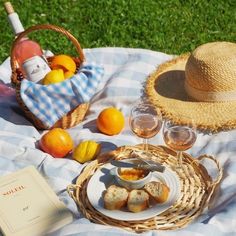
[[185, 42, 236, 101]]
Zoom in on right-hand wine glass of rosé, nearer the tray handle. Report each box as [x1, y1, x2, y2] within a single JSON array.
[[163, 118, 197, 168]]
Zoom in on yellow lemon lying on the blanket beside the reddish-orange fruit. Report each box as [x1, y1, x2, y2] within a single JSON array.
[[72, 140, 101, 163]]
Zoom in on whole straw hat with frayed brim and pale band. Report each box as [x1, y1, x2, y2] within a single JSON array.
[[146, 42, 236, 132]]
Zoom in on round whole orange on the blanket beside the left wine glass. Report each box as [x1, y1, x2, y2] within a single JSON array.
[[96, 107, 125, 135]]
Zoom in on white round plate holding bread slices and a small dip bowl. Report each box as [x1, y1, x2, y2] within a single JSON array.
[[87, 164, 181, 221]]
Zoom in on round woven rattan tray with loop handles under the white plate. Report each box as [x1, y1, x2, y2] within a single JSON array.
[[67, 145, 223, 233]]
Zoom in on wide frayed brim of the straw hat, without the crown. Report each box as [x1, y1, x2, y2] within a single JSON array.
[[146, 54, 236, 132]]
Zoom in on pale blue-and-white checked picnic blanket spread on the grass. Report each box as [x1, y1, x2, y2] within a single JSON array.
[[0, 48, 236, 236]]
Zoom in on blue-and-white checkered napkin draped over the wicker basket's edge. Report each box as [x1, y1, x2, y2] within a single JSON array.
[[20, 63, 104, 127]]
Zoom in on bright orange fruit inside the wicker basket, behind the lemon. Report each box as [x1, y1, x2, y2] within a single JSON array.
[[50, 54, 76, 73]]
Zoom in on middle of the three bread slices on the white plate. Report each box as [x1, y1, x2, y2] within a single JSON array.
[[127, 189, 149, 213]]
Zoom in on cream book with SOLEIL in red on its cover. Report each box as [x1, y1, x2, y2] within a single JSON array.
[[0, 166, 72, 236]]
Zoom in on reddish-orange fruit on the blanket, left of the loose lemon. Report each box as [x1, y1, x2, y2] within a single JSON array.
[[39, 128, 74, 158]]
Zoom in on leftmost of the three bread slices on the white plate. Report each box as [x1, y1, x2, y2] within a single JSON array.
[[103, 185, 129, 210]]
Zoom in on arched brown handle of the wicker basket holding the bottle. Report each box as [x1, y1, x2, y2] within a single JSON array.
[[10, 24, 85, 84]]
